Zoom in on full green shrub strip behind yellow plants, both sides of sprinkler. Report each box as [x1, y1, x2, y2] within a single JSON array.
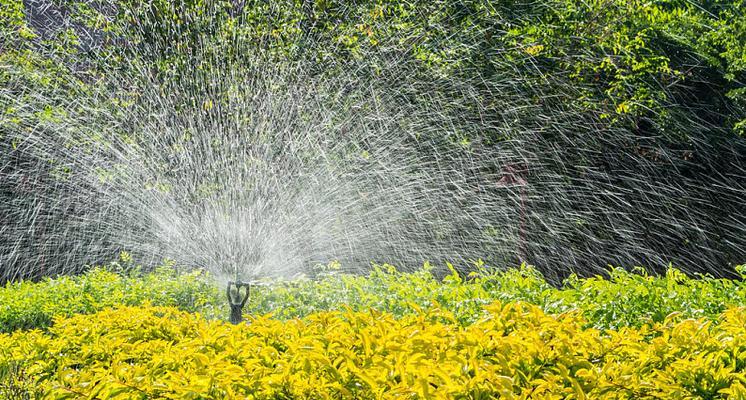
[[0, 264, 746, 332]]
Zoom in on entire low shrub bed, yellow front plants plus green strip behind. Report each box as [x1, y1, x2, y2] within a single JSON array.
[[0, 265, 746, 399]]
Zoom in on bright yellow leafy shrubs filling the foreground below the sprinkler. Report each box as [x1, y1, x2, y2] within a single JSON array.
[[0, 303, 746, 399]]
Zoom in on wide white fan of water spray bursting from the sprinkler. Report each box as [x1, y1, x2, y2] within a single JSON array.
[[0, 0, 746, 284]]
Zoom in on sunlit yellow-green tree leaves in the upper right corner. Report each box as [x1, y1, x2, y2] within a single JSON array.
[[494, 0, 746, 133]]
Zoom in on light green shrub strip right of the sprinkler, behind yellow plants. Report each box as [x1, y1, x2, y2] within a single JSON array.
[[246, 265, 746, 330]]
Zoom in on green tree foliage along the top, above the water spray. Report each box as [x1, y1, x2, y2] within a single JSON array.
[[0, 0, 746, 135]]
